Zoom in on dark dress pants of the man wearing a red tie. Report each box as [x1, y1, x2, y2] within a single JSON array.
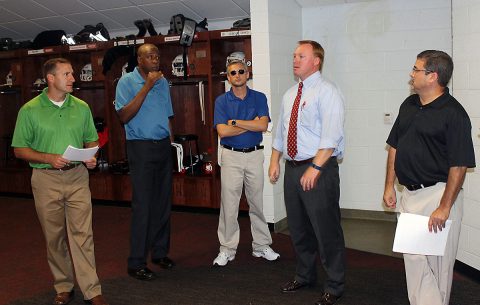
[[284, 158, 345, 295]]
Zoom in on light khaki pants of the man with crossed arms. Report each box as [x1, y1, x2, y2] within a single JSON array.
[[217, 148, 272, 254]]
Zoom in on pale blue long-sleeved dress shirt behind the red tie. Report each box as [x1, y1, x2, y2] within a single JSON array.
[[273, 71, 345, 161]]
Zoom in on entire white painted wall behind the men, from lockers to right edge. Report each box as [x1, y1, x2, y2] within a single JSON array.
[[250, 0, 480, 269]]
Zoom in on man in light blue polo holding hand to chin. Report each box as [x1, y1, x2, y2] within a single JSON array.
[[115, 44, 174, 281]]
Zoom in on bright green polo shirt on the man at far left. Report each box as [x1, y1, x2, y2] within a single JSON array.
[[12, 88, 98, 168]]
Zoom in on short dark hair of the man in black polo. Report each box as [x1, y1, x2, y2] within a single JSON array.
[[417, 50, 453, 87]]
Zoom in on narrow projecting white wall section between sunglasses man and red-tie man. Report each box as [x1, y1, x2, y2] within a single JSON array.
[[250, 0, 302, 223]]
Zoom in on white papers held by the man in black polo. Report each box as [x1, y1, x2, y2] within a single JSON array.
[[393, 213, 452, 256]]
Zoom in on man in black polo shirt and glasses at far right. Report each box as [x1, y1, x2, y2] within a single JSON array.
[[383, 50, 475, 305]]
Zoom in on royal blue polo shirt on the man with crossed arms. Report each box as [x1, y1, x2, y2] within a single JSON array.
[[213, 87, 270, 148]]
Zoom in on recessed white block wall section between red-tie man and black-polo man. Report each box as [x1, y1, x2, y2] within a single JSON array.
[[302, 0, 452, 211]]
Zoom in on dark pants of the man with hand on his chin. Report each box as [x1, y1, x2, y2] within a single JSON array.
[[127, 138, 173, 269]]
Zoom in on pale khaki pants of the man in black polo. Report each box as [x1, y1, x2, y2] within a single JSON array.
[[399, 183, 463, 305]]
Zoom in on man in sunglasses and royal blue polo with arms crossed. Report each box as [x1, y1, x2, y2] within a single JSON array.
[[213, 61, 280, 266]]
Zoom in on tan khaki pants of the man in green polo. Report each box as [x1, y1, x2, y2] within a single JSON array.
[[32, 165, 102, 299]]
